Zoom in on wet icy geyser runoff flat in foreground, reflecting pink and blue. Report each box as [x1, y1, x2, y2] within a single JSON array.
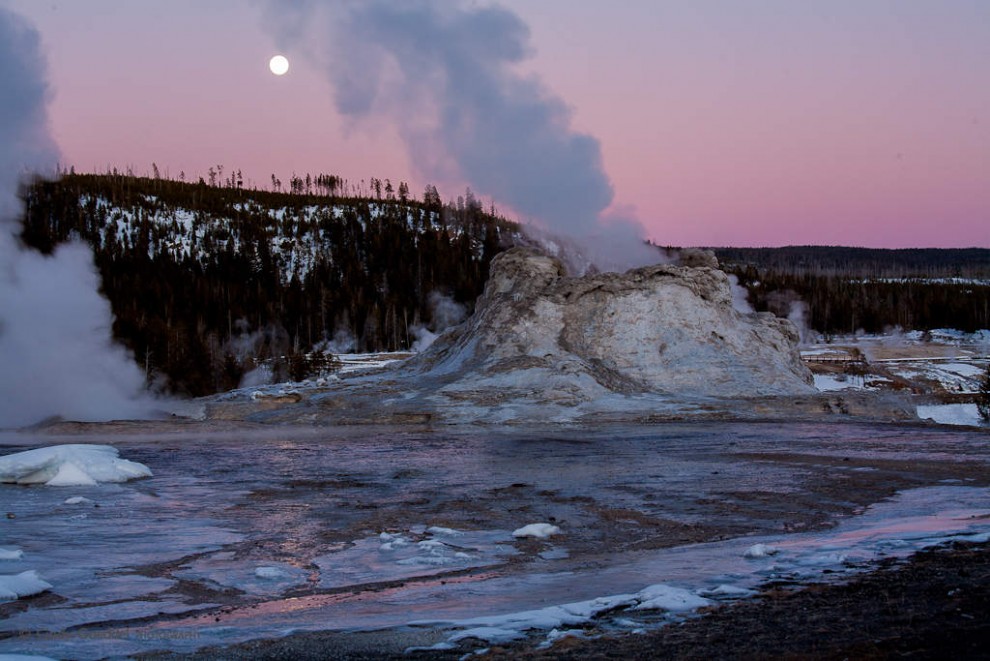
[[0, 423, 990, 658]]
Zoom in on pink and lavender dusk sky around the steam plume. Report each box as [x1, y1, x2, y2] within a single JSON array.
[[7, 0, 990, 247]]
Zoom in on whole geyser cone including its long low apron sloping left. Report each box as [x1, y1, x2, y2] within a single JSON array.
[[207, 248, 848, 424]]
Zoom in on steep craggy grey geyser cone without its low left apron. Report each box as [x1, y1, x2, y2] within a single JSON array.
[[407, 248, 815, 403]]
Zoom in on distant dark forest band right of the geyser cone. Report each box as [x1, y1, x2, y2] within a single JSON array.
[[715, 246, 990, 335]]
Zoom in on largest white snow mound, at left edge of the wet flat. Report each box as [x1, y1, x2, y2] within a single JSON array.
[[0, 444, 151, 487]]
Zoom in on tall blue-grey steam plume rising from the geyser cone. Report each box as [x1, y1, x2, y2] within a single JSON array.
[[267, 0, 659, 269]]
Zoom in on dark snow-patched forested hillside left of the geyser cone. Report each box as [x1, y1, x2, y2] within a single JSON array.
[[22, 173, 516, 395]]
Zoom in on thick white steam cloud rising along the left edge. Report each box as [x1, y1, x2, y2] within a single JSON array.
[[0, 7, 161, 427]]
